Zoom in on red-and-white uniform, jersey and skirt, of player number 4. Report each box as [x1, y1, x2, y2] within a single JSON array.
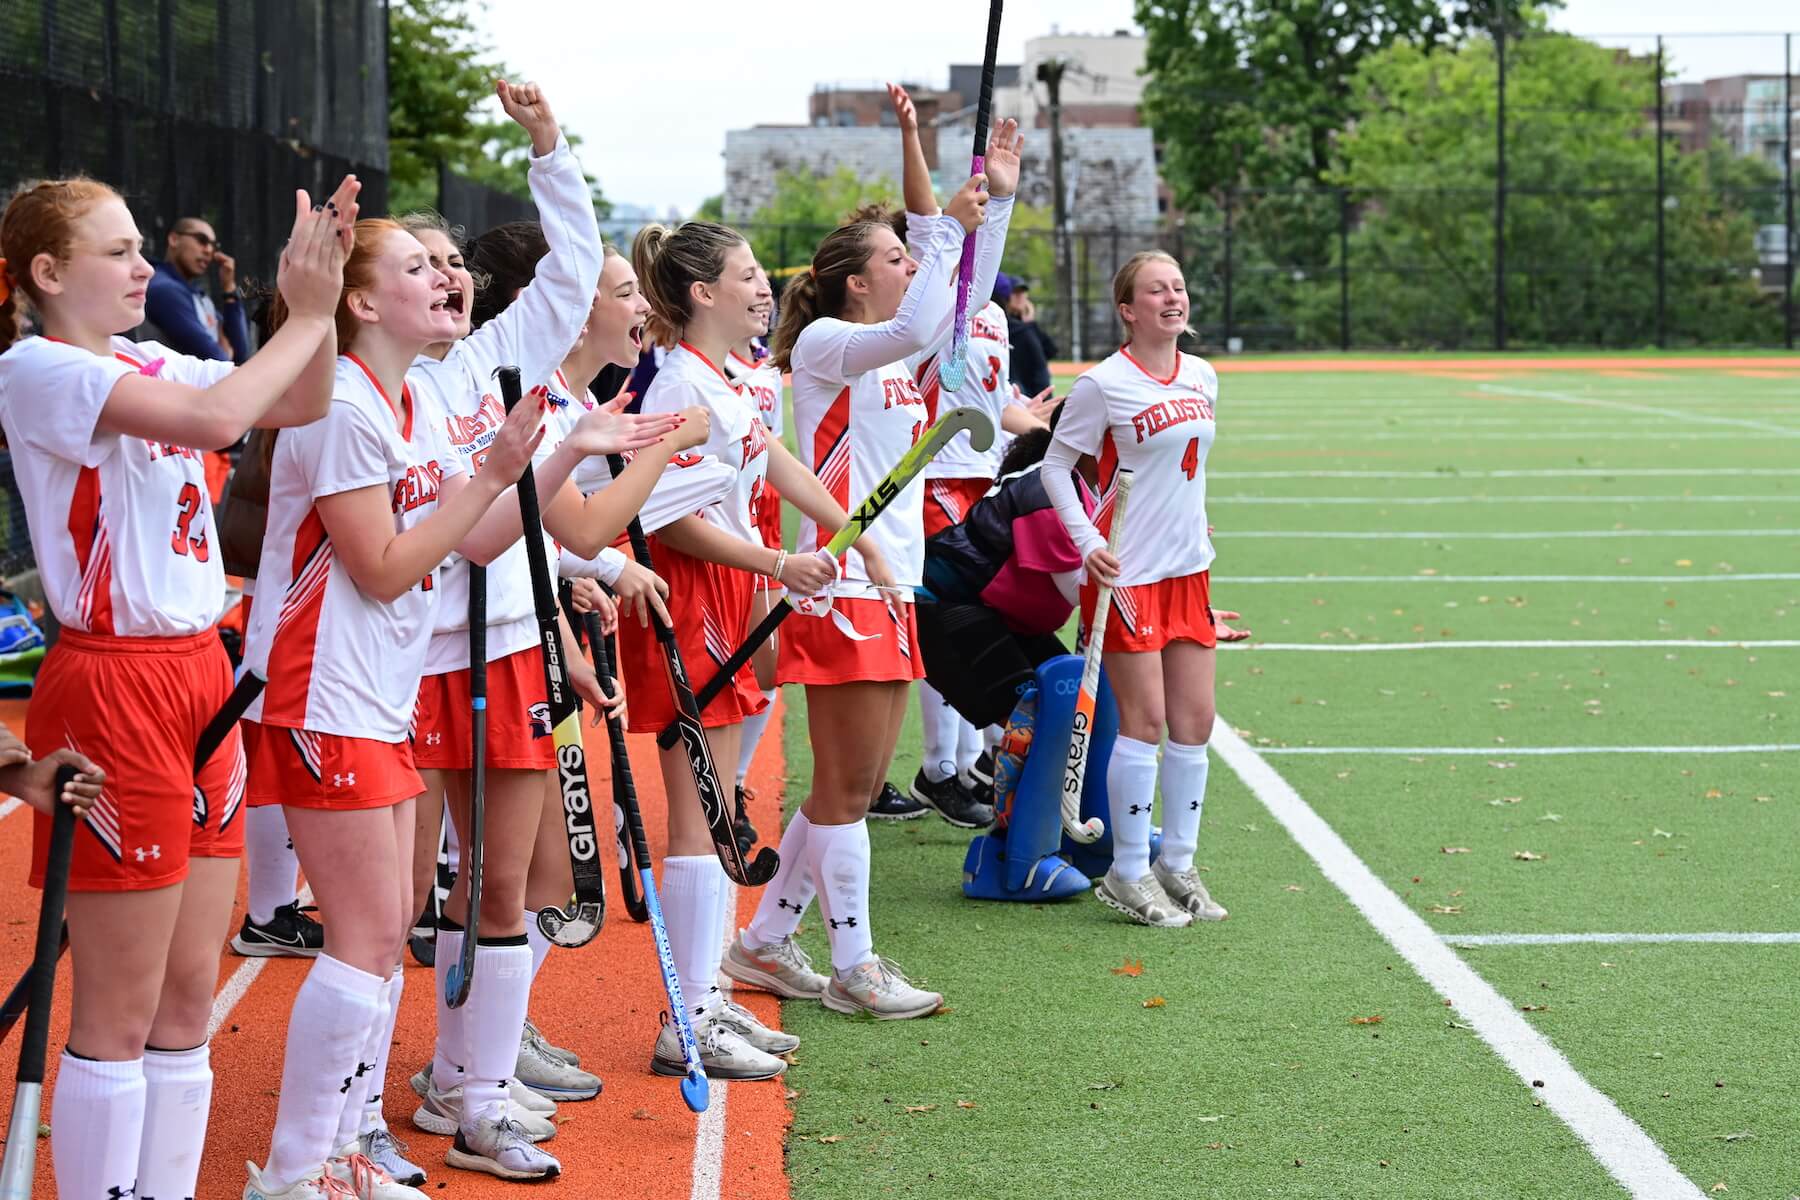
[[1046, 347, 1219, 649]]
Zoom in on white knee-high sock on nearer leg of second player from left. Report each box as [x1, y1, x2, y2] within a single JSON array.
[[263, 954, 383, 1191]]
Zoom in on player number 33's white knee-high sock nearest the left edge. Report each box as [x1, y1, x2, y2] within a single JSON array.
[[50, 1051, 146, 1196]]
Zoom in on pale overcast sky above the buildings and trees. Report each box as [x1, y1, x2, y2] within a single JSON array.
[[484, 0, 1800, 212]]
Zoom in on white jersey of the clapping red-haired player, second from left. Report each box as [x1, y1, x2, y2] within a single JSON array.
[[245, 354, 463, 741]]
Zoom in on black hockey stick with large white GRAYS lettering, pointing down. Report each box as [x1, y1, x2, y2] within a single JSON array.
[[499, 367, 607, 946]]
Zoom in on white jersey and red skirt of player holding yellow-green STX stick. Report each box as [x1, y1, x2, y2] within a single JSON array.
[[619, 342, 769, 732]]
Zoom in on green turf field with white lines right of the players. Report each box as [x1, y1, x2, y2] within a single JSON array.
[[783, 358, 1800, 1200]]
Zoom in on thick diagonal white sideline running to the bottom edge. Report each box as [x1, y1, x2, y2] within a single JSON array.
[[1211, 718, 1701, 1200]]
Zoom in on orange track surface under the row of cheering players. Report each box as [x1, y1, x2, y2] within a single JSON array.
[[0, 700, 790, 1200]]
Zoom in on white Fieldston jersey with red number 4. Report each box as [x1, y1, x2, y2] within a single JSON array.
[[1057, 347, 1219, 587]]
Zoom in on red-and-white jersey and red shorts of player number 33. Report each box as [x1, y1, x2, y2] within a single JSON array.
[[0, 338, 245, 891]]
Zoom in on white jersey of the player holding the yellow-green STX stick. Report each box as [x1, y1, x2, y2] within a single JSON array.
[[643, 342, 769, 545]]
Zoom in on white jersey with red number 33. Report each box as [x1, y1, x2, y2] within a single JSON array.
[[0, 338, 232, 637]]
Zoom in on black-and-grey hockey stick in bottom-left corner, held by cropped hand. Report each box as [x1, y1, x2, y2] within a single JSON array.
[[0, 766, 76, 1200]]
